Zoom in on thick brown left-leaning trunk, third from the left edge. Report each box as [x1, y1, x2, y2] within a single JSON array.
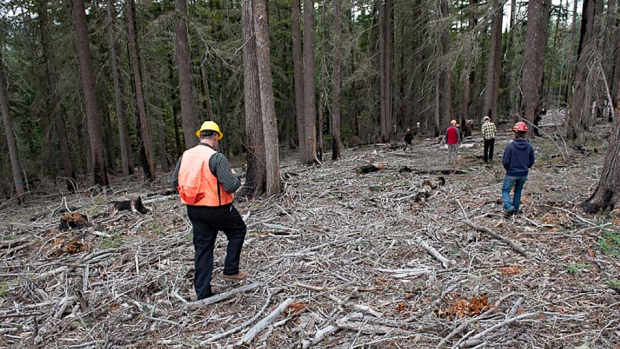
[[72, 0, 108, 186]]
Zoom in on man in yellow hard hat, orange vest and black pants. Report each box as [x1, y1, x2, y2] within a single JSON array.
[[173, 121, 248, 300]]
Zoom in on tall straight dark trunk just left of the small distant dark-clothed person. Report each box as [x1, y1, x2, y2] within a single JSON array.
[[380, 0, 393, 142]]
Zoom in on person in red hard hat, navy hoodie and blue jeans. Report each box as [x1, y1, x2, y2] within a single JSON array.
[[502, 121, 535, 218]]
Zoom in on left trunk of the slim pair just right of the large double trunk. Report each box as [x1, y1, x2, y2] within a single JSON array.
[[291, 0, 306, 154]]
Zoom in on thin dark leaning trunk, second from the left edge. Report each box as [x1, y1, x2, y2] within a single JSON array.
[[38, 0, 75, 190]]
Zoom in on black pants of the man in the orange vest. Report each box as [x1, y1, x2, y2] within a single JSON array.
[[187, 204, 246, 299]]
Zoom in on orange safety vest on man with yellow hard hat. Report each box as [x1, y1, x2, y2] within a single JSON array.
[[177, 144, 235, 207]]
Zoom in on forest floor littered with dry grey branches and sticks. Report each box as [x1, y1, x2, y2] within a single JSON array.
[[0, 120, 620, 349]]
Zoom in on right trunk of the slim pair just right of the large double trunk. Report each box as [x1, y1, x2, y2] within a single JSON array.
[[303, 0, 316, 164]]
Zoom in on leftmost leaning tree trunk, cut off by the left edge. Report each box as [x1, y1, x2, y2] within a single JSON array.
[[0, 45, 24, 201]]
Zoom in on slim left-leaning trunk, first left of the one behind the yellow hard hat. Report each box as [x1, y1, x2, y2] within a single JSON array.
[[126, 0, 155, 180]]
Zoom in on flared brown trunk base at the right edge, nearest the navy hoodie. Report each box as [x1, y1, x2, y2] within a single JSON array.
[[583, 118, 620, 213]]
